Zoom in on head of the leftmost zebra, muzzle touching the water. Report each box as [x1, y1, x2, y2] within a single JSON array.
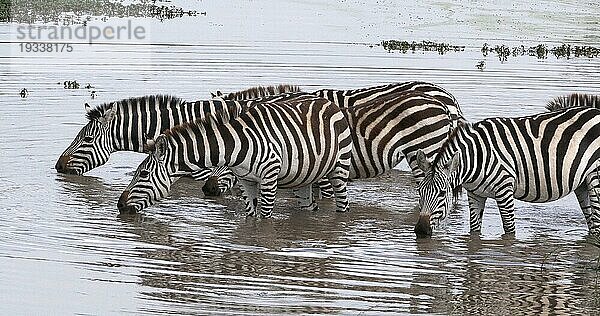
[[55, 103, 117, 175]]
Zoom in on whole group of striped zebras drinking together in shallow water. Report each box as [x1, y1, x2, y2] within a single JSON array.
[[55, 81, 600, 237]]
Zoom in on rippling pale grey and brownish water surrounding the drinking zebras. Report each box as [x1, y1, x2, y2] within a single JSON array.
[[0, 1, 600, 315]]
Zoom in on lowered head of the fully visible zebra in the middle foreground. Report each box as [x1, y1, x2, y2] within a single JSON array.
[[117, 135, 177, 214]]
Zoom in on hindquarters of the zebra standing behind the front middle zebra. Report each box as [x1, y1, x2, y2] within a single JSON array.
[[216, 81, 464, 197]]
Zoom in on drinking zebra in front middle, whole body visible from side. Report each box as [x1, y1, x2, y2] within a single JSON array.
[[117, 96, 352, 217]]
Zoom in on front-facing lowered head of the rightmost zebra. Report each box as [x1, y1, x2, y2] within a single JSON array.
[[415, 150, 460, 237]]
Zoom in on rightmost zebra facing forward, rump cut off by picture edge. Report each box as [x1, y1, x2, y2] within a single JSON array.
[[415, 94, 600, 236]]
